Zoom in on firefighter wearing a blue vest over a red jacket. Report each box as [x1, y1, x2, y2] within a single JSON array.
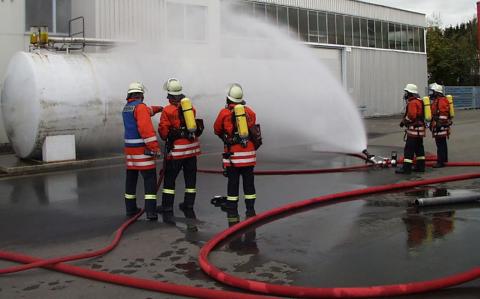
[[122, 82, 163, 220]]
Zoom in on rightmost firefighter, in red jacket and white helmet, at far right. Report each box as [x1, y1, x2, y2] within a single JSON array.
[[429, 83, 452, 168]]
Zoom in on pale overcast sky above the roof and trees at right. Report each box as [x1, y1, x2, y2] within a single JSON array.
[[363, 0, 477, 27]]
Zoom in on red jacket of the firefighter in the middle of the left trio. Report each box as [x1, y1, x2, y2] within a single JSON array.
[[158, 104, 201, 160]]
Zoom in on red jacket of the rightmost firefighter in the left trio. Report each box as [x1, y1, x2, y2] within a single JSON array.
[[213, 104, 257, 167]]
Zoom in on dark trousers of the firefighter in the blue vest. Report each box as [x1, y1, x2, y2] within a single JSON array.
[[125, 169, 157, 218]]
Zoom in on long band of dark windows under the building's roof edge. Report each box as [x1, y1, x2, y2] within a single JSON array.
[[234, 0, 425, 52]]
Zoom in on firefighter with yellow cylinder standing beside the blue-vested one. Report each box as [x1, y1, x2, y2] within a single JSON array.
[[158, 78, 203, 224]]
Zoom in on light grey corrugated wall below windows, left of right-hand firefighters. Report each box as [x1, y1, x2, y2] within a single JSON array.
[[346, 48, 428, 116]]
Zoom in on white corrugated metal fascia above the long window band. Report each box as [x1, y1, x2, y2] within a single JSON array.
[[255, 0, 426, 27]]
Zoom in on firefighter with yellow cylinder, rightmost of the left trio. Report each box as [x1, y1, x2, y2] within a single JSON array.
[[214, 84, 259, 219]]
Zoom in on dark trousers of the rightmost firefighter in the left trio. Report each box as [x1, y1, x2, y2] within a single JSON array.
[[227, 166, 257, 213]]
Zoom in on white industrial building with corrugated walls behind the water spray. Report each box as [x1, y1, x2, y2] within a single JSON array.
[[0, 0, 427, 152]]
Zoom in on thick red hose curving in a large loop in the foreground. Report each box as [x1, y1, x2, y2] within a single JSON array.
[[199, 170, 480, 298]]
